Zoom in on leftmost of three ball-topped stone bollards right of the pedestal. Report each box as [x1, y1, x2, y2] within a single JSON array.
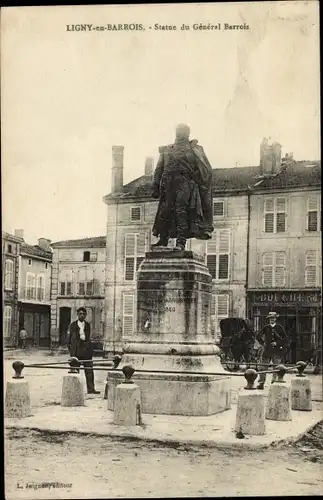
[[235, 368, 266, 436]]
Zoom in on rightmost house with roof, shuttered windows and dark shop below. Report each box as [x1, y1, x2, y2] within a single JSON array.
[[247, 148, 322, 363]]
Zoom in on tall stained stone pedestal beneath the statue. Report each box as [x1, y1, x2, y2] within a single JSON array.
[[108, 248, 231, 415]]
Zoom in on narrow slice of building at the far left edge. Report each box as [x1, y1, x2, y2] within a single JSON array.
[[2, 232, 23, 347]]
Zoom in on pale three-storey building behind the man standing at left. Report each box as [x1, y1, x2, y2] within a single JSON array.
[[51, 236, 106, 348]]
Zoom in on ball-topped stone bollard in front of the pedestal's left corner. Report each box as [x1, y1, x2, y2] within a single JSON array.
[[113, 366, 141, 426]]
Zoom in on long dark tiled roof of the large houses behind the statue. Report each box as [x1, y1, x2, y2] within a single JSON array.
[[104, 161, 321, 203]]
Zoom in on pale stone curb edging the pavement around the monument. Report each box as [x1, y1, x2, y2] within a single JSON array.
[[5, 420, 323, 451]]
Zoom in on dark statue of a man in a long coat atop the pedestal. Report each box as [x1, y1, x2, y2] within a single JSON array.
[[152, 124, 214, 250]]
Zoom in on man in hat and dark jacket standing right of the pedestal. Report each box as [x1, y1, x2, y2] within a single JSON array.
[[256, 312, 289, 389]]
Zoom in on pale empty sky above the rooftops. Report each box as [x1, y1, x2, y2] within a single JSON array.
[[1, 1, 320, 244]]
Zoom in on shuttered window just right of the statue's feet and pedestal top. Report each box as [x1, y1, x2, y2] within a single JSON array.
[[206, 229, 230, 280]]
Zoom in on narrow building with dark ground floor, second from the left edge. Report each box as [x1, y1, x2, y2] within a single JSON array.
[[18, 238, 52, 347]]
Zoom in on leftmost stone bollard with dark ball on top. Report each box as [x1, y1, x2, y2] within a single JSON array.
[[5, 361, 31, 418]]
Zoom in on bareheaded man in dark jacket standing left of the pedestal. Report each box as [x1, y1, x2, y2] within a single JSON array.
[[68, 307, 100, 394]]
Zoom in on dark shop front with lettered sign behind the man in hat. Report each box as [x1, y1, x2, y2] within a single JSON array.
[[247, 289, 322, 363]]
